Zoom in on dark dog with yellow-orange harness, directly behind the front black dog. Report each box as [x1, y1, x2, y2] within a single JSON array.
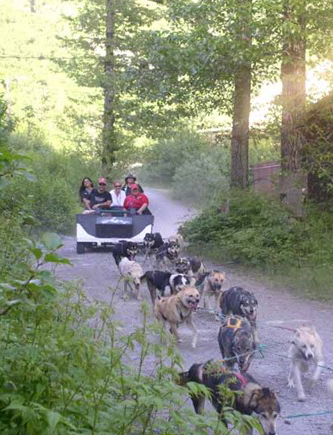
[[217, 316, 256, 372]]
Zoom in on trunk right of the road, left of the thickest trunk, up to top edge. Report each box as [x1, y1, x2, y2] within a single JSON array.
[[231, 0, 252, 189]]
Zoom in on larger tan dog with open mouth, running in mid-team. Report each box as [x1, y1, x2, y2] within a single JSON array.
[[154, 286, 200, 348]]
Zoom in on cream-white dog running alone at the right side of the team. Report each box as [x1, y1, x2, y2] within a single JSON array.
[[288, 326, 324, 402]]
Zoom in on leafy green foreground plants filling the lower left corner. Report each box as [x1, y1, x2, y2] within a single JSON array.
[[0, 238, 258, 435]]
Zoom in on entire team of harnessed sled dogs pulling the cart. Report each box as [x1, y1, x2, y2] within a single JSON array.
[[113, 233, 333, 435]]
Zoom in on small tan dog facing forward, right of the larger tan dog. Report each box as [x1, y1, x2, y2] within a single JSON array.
[[196, 270, 226, 310]]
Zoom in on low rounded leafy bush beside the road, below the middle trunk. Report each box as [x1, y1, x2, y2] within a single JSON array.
[[183, 192, 306, 265]]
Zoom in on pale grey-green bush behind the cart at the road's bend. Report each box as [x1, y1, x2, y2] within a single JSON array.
[[140, 130, 230, 206]]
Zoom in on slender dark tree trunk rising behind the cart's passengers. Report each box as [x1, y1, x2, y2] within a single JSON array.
[[102, 0, 118, 174]]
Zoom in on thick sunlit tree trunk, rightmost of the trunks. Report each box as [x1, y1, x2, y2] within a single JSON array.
[[281, 5, 306, 172]]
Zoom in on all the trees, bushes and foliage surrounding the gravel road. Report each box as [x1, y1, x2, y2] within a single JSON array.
[[0, 0, 333, 435]]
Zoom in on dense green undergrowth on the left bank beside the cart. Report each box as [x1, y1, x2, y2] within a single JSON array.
[[0, 127, 100, 277]]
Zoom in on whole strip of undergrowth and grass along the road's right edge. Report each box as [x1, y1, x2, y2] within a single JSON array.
[[183, 192, 333, 299]]
